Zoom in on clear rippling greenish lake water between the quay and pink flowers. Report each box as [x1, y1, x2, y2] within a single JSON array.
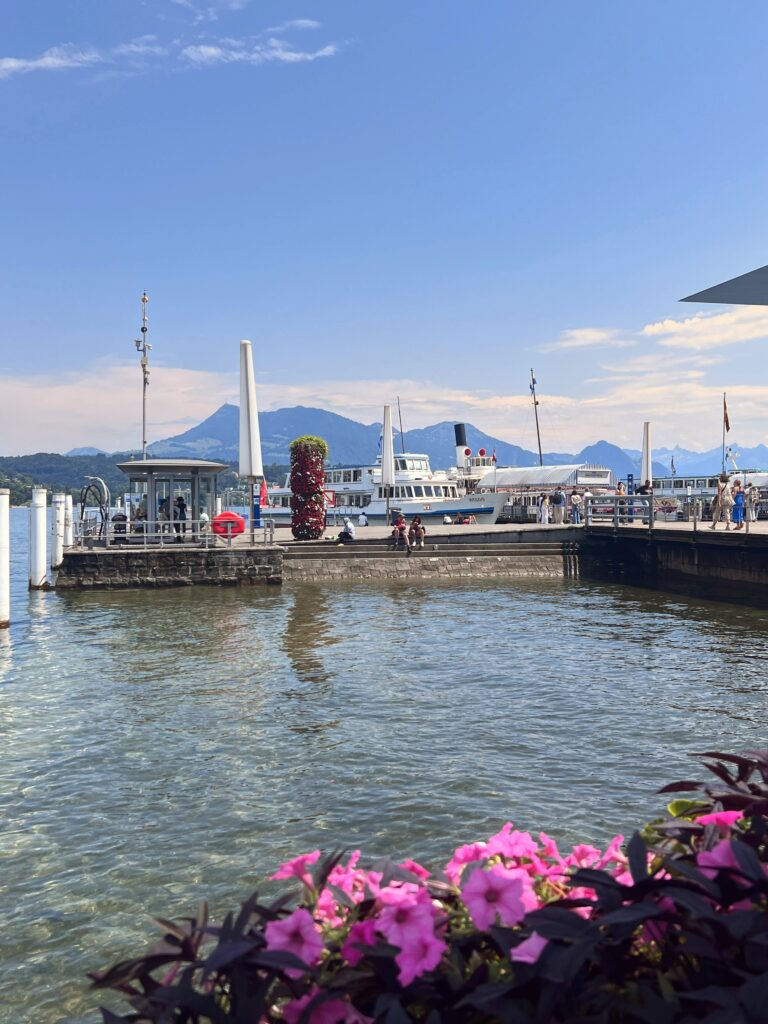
[[0, 510, 768, 1024]]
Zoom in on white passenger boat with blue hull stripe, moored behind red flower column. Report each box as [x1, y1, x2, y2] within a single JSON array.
[[261, 452, 507, 525]]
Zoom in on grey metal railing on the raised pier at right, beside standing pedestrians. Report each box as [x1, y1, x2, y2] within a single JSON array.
[[584, 495, 758, 534]]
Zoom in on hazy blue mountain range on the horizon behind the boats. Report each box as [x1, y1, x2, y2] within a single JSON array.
[[138, 404, 668, 478]]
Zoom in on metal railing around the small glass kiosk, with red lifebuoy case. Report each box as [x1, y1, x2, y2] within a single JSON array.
[[72, 512, 274, 550]]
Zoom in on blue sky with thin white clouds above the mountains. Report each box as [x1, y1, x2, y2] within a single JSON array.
[[0, 0, 768, 454]]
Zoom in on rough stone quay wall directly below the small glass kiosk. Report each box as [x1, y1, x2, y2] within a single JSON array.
[[55, 546, 283, 590]]
